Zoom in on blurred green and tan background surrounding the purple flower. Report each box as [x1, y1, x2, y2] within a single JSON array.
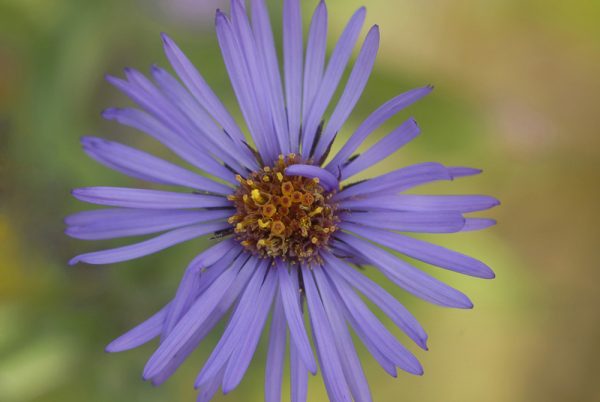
[[0, 0, 600, 402]]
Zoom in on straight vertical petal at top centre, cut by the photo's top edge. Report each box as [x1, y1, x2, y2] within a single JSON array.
[[283, 0, 303, 152]]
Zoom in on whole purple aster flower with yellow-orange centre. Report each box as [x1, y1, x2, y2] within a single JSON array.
[[66, 0, 498, 401]]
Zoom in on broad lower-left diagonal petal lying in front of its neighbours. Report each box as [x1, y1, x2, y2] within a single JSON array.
[[144, 269, 238, 379]]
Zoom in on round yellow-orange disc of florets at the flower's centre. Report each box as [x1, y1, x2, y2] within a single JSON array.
[[229, 154, 339, 263]]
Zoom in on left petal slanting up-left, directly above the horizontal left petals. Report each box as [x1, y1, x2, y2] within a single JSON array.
[[81, 137, 232, 194]]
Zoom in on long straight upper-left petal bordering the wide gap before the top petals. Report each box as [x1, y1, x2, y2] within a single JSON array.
[[161, 33, 246, 151]]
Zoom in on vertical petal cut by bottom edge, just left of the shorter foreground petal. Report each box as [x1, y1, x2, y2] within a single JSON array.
[[265, 296, 287, 402]]
